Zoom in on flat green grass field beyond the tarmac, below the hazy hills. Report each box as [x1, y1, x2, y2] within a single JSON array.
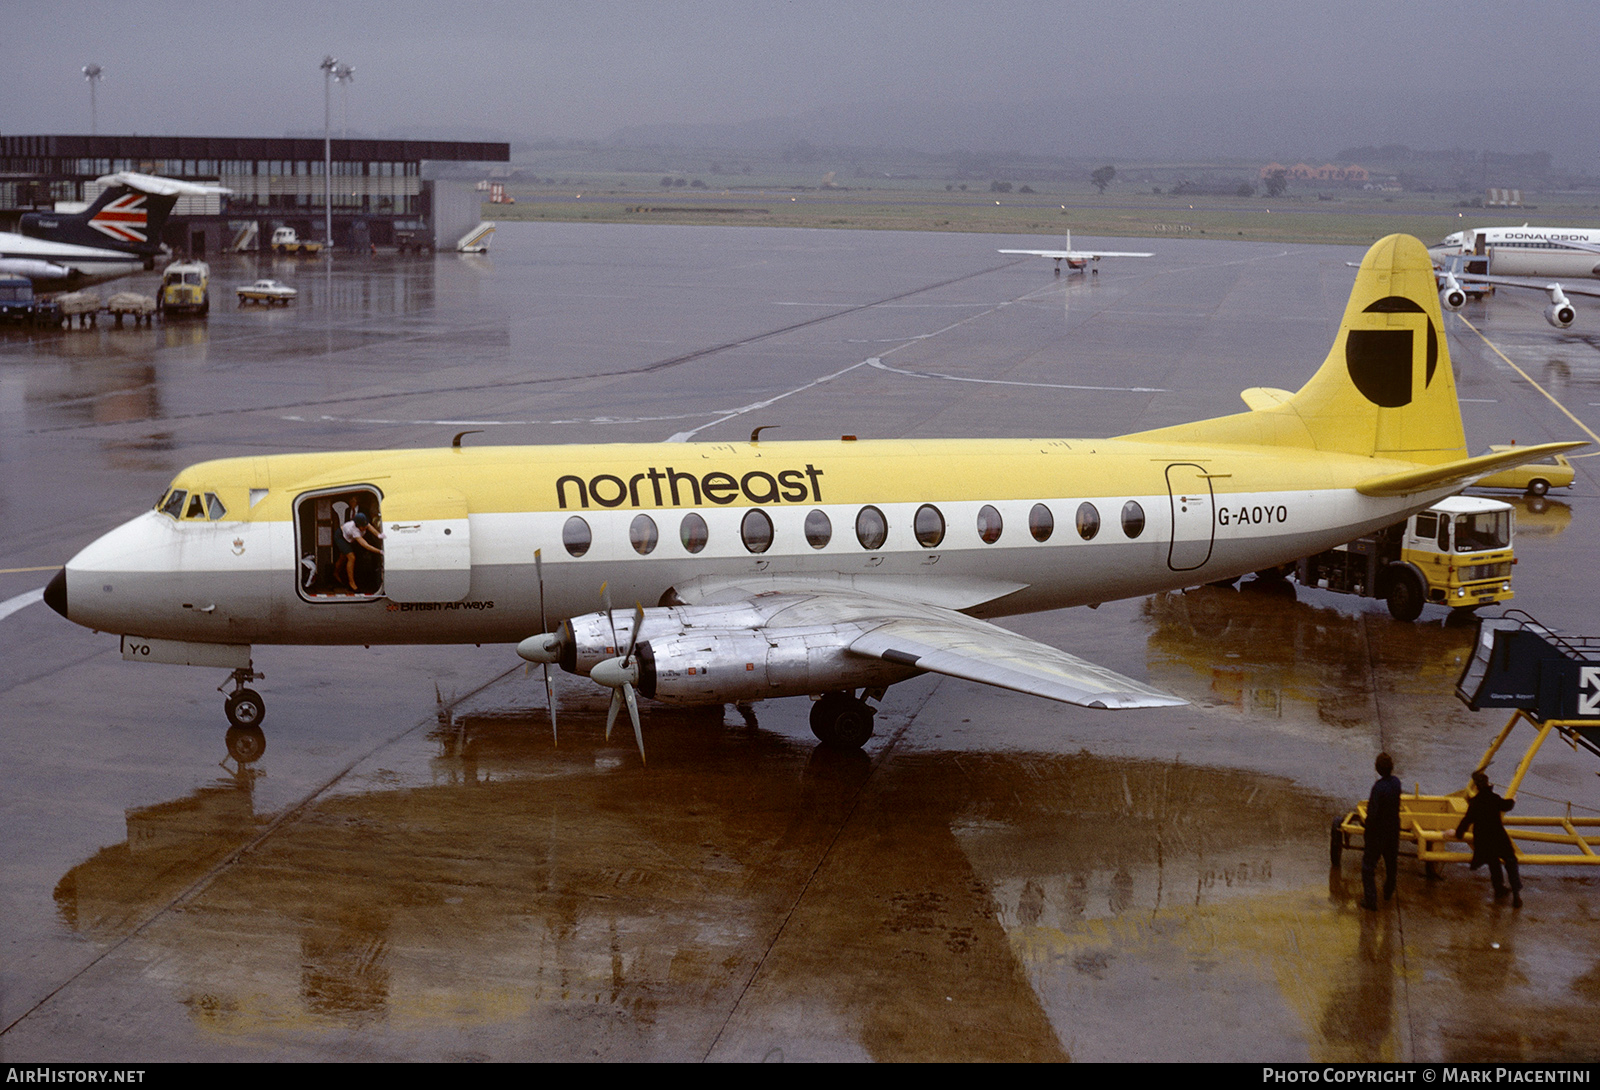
[[483, 178, 1600, 245]]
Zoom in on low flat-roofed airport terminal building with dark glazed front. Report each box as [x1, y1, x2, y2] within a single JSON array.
[[0, 136, 510, 258]]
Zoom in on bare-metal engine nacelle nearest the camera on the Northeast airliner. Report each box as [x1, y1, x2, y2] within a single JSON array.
[[637, 624, 922, 704]]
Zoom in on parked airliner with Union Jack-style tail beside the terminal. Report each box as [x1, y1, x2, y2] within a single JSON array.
[[0, 171, 230, 291]]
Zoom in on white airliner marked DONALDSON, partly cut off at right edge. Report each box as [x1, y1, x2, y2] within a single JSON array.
[[1427, 224, 1600, 330]]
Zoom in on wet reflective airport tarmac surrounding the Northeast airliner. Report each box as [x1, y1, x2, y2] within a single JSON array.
[[0, 224, 1600, 1061]]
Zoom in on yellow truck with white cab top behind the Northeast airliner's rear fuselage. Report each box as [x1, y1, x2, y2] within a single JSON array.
[[1294, 496, 1517, 621]]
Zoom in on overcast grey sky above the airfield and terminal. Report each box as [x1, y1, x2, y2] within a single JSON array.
[[0, 0, 1600, 170]]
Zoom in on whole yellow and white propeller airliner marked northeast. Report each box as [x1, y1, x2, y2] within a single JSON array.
[[45, 235, 1584, 755]]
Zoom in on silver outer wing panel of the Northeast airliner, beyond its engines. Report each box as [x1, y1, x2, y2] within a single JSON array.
[[850, 615, 1189, 709]]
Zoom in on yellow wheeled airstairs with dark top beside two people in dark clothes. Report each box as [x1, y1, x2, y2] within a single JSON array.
[[1330, 610, 1600, 874]]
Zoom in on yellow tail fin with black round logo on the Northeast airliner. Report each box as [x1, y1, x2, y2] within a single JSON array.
[[1126, 235, 1467, 464]]
